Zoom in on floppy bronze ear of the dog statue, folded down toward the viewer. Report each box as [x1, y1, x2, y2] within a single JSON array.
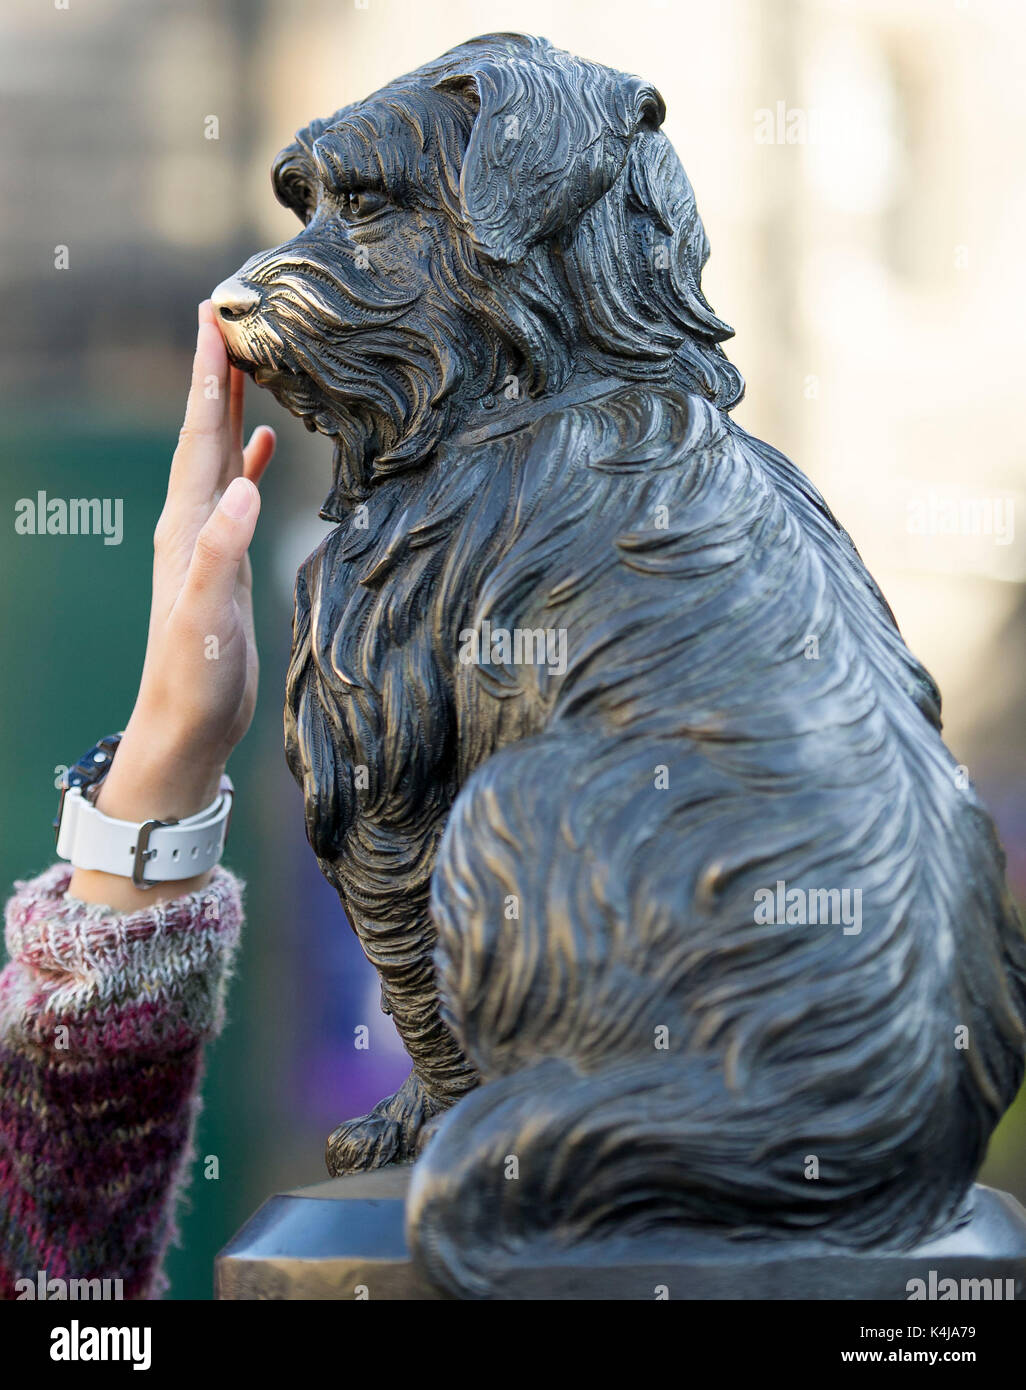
[[435, 43, 666, 265]]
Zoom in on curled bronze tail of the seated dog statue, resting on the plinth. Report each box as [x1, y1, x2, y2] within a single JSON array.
[[407, 1056, 979, 1300]]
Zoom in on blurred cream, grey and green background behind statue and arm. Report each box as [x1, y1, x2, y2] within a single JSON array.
[[0, 0, 1026, 1298]]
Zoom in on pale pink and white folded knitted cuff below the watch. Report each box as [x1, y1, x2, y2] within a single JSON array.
[[0, 865, 242, 1056]]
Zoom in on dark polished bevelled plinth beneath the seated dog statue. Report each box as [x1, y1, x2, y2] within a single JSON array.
[[214, 1168, 1026, 1301]]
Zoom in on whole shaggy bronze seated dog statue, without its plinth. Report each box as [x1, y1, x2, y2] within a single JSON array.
[[215, 35, 1026, 1295]]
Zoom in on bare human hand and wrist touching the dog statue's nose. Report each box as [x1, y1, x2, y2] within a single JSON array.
[[70, 300, 275, 910]]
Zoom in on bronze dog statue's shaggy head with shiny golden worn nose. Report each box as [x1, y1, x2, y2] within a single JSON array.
[[213, 35, 742, 520]]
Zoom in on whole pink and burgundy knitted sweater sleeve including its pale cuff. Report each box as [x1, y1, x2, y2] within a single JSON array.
[[0, 865, 242, 1298]]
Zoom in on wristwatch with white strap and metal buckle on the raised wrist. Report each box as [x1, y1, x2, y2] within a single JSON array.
[[53, 734, 235, 888]]
